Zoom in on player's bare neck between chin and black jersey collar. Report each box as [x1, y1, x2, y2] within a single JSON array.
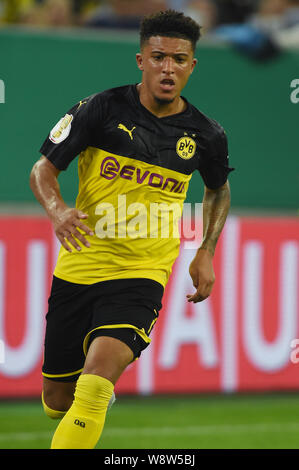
[[137, 83, 186, 118]]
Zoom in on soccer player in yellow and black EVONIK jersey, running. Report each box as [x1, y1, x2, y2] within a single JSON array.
[[30, 10, 231, 449]]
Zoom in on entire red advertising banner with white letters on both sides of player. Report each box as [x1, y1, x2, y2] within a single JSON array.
[[0, 217, 299, 397]]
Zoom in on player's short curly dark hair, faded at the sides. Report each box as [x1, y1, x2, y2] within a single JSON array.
[[140, 10, 201, 52]]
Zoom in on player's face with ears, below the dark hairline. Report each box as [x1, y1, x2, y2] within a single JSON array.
[[136, 36, 197, 103]]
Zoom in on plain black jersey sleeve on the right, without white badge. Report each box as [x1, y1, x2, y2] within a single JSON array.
[[198, 128, 234, 189]]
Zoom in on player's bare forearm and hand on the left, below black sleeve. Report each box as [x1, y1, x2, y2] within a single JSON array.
[[30, 155, 93, 252]]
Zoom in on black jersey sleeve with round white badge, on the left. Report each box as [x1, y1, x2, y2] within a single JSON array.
[[40, 95, 100, 170]]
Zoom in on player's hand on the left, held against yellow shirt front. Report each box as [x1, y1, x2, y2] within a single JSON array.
[[51, 206, 94, 253]]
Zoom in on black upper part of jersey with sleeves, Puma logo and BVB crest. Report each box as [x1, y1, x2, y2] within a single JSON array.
[[40, 85, 236, 188]]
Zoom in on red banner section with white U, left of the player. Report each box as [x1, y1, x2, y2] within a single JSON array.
[[0, 217, 54, 396]]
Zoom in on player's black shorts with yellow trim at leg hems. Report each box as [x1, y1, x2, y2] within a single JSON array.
[[42, 276, 164, 382]]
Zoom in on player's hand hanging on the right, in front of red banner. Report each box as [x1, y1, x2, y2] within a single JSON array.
[[186, 248, 215, 303]]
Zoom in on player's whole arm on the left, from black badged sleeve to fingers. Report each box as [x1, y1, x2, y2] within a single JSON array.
[[30, 95, 100, 252]]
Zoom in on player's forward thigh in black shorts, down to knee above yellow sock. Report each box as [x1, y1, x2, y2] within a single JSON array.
[[83, 279, 163, 383]]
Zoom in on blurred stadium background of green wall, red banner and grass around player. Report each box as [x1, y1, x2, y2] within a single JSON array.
[[0, 0, 299, 449]]
